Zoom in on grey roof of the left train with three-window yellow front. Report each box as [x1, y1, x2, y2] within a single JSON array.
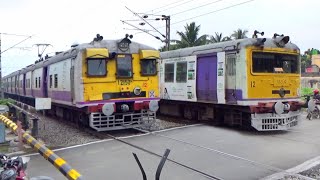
[[3, 39, 156, 78]]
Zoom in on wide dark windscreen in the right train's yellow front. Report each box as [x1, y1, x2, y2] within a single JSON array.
[[252, 52, 300, 74]]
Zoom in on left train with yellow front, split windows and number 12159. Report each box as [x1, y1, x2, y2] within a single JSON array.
[[3, 35, 160, 131]]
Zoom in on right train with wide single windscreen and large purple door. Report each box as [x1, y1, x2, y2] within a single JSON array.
[[160, 31, 302, 131]]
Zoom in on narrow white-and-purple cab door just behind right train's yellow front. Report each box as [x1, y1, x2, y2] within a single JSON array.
[[226, 53, 237, 103]]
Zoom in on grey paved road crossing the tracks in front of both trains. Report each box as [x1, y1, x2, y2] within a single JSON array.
[[28, 117, 320, 180]]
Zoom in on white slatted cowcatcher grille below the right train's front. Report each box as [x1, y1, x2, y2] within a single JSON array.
[[251, 111, 301, 131]]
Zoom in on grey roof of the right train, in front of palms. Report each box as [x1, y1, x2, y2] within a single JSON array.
[[160, 38, 299, 59]]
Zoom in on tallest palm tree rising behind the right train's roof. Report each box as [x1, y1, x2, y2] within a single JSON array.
[[170, 22, 208, 49]]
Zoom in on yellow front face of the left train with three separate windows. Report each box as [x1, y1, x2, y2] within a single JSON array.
[[82, 39, 159, 131]]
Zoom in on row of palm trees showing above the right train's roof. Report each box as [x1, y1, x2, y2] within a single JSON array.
[[159, 22, 248, 51]]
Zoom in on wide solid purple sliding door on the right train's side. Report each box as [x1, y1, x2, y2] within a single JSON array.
[[196, 54, 217, 101]]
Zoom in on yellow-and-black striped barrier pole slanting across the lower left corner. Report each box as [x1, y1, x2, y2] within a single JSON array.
[[0, 115, 83, 180]]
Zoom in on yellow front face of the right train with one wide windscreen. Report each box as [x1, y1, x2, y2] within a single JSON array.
[[246, 37, 301, 131]]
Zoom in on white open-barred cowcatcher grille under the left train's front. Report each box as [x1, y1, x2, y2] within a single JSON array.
[[89, 110, 156, 131]]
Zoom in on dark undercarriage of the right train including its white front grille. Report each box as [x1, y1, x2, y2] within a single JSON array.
[[159, 100, 300, 131]]
